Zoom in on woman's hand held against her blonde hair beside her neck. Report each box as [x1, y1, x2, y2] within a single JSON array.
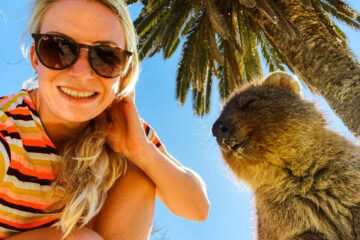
[[106, 96, 149, 165]]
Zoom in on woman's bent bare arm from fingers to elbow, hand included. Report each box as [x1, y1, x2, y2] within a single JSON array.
[[107, 97, 209, 221]]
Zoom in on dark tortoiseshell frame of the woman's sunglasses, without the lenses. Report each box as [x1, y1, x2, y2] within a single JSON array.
[[31, 33, 133, 78]]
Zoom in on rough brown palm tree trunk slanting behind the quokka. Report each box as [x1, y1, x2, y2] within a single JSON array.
[[253, 0, 360, 137]]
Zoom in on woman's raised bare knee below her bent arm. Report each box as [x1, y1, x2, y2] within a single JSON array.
[[90, 163, 156, 240]]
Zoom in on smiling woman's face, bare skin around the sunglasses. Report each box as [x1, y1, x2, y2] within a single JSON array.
[[31, 0, 126, 123]]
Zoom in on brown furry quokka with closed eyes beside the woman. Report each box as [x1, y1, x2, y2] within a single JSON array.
[[213, 72, 360, 240]]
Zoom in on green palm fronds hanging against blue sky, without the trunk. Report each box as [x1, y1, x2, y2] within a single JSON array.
[[131, 0, 360, 115]]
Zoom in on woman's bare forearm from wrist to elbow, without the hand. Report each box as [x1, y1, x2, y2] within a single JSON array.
[[133, 144, 209, 221]]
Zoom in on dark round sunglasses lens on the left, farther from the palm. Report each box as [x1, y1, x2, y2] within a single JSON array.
[[37, 36, 77, 69]]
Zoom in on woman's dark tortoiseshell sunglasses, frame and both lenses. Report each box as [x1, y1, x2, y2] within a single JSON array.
[[32, 33, 132, 78]]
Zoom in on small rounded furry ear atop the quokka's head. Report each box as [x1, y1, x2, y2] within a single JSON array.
[[263, 71, 300, 94]]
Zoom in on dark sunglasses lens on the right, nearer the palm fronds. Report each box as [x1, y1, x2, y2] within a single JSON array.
[[89, 46, 128, 78]]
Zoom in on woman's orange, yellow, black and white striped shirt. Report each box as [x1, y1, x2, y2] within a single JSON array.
[[0, 90, 166, 239]]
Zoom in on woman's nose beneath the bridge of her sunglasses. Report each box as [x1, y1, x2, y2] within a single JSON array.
[[69, 49, 93, 80]]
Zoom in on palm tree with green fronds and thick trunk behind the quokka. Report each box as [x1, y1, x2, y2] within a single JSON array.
[[127, 0, 360, 136]]
